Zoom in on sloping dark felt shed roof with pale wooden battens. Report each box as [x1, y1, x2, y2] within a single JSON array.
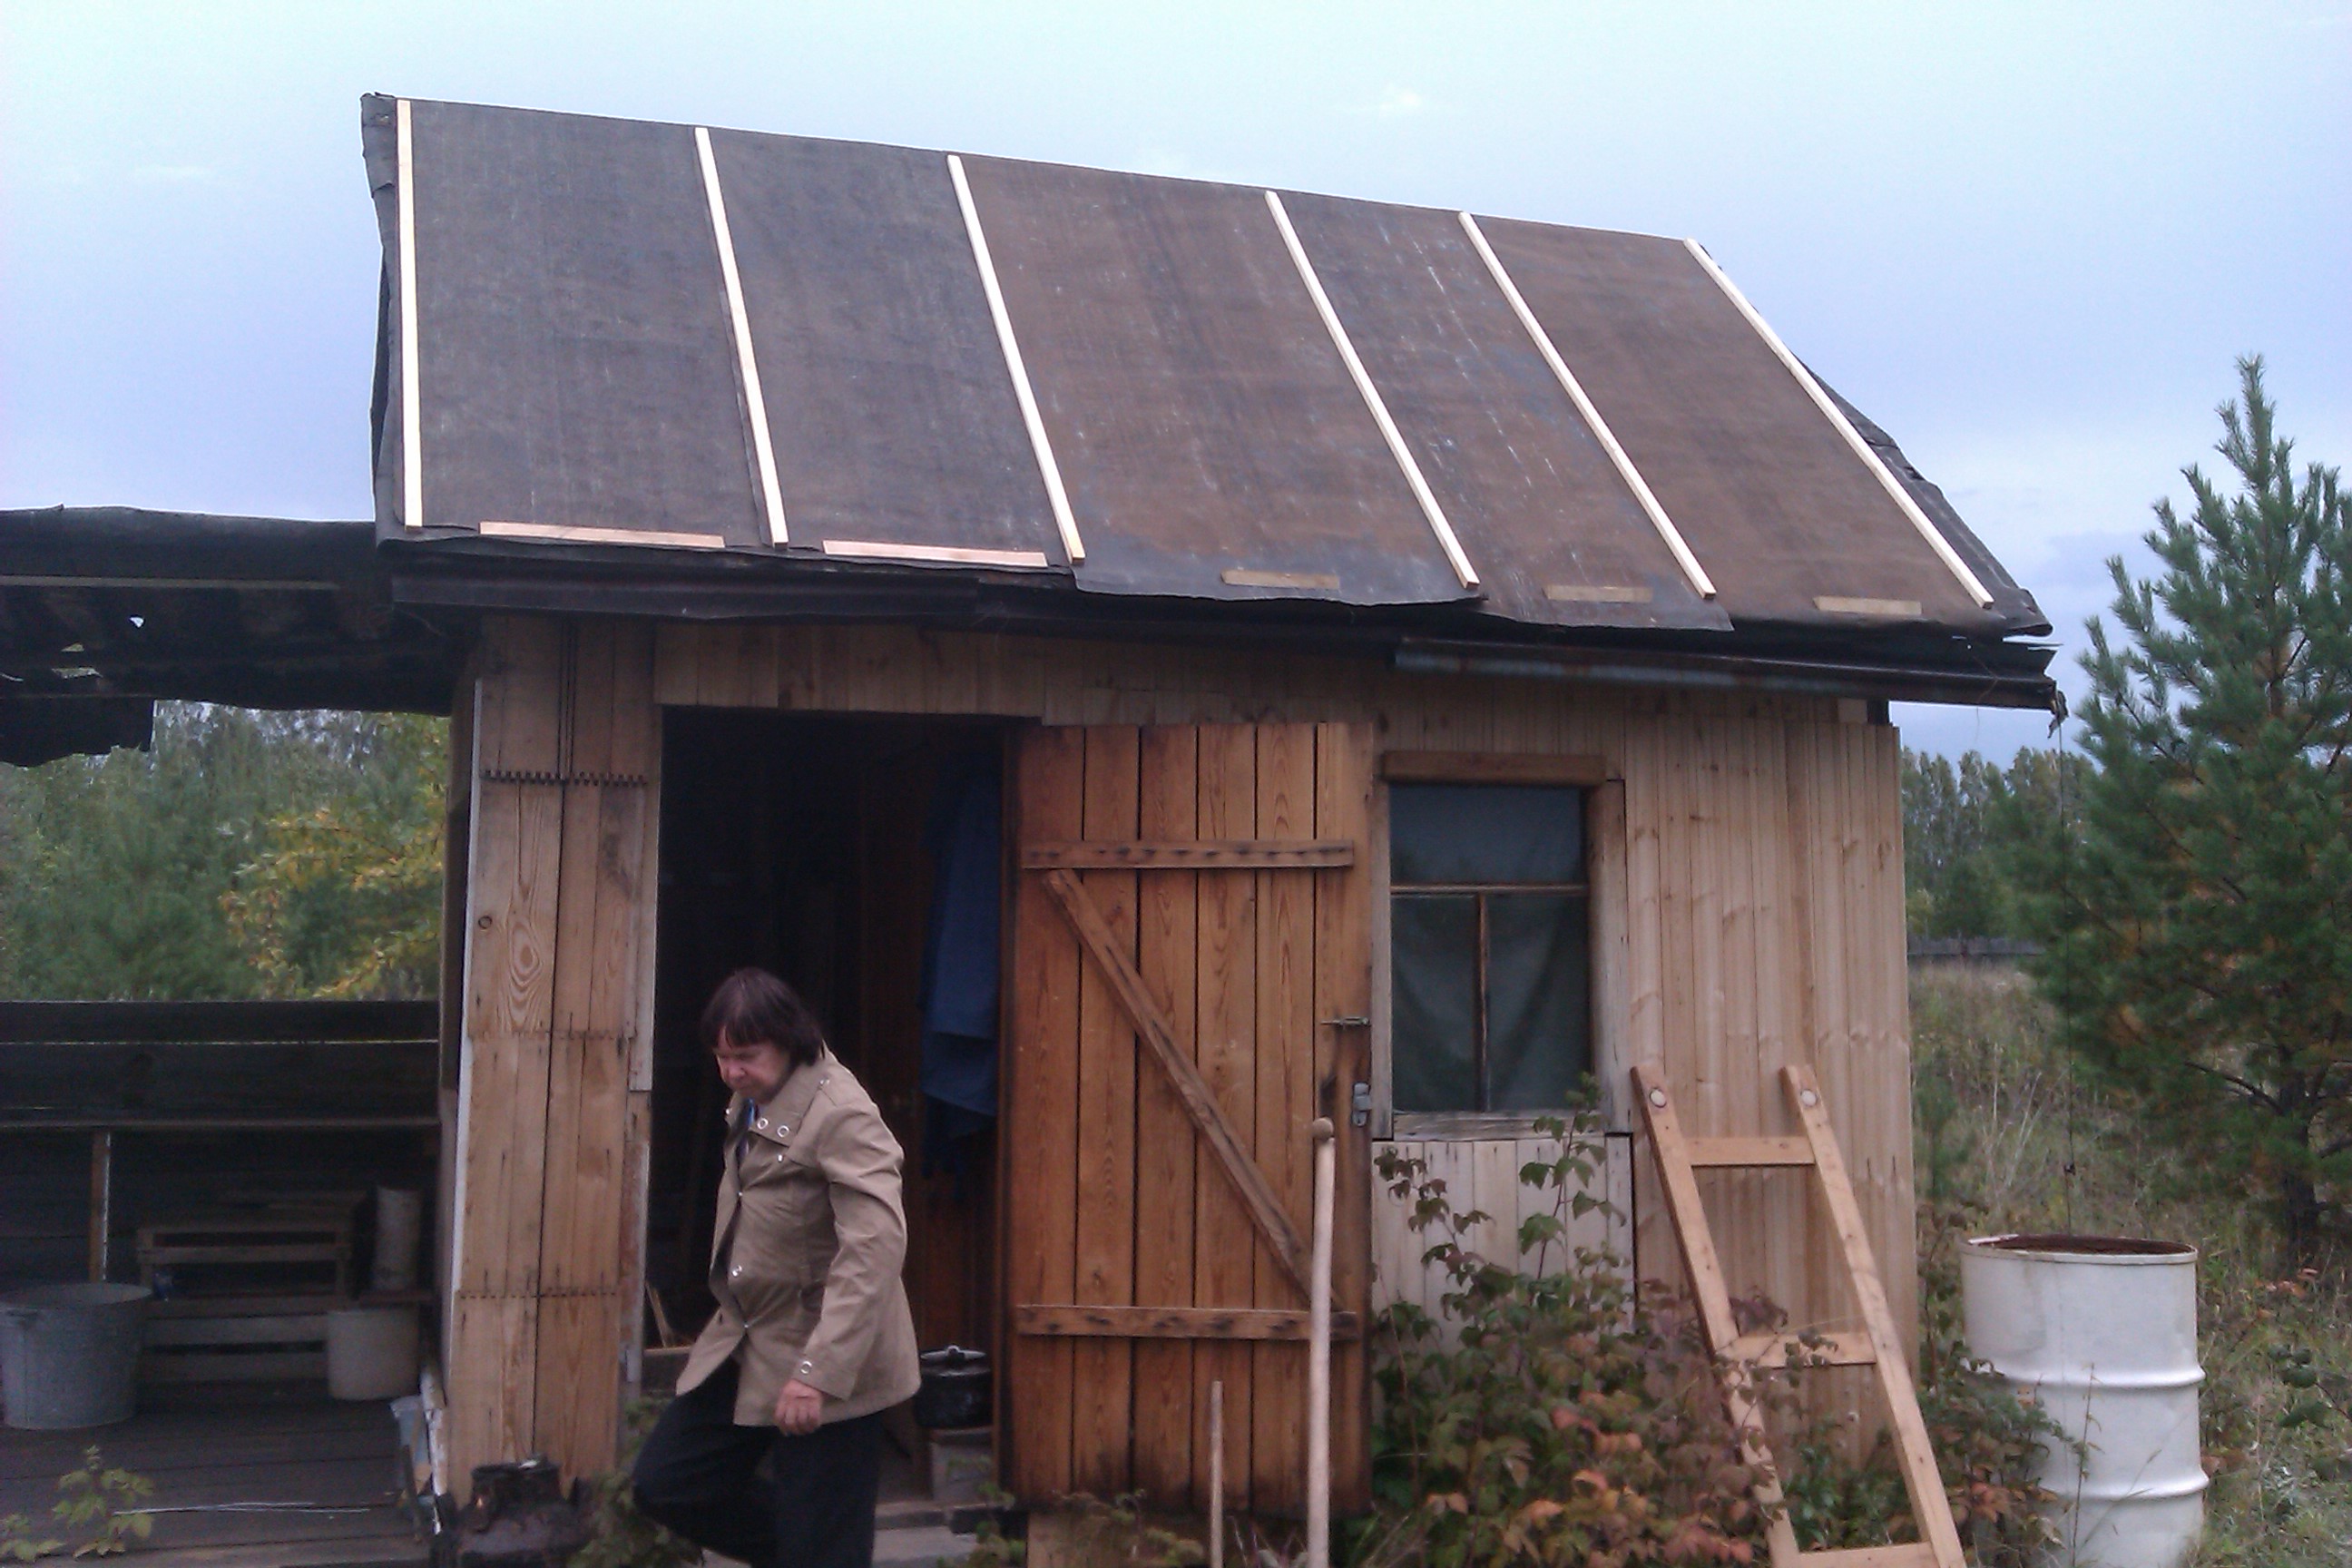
[[362, 96, 2049, 701]]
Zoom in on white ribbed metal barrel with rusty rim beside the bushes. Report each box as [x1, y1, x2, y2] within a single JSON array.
[[1959, 1237, 2206, 1568]]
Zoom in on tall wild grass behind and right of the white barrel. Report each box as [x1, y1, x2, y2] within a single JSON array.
[[1912, 971, 2352, 1568]]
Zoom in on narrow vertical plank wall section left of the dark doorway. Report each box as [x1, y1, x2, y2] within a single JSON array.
[[442, 621, 661, 1488]]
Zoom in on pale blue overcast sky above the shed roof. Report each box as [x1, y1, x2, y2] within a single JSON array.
[[0, 0, 2352, 755]]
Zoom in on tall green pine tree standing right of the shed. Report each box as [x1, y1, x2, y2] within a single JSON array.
[[2018, 359, 2352, 1260]]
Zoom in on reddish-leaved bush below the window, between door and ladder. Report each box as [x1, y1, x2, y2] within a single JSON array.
[[1355, 1112, 1764, 1568]]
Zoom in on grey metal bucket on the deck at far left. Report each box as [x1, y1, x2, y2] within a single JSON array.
[[0, 1286, 148, 1432]]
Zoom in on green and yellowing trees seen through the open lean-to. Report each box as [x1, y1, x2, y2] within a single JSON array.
[[0, 703, 446, 999]]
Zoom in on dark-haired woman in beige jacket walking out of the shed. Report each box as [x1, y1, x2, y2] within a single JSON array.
[[632, 968, 919, 1568]]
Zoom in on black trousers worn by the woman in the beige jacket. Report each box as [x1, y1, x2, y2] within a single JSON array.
[[631, 1361, 882, 1568]]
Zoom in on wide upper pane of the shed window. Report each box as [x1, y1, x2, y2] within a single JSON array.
[[1387, 785, 1585, 882]]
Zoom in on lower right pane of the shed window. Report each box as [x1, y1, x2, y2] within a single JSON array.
[[1486, 893, 1592, 1110]]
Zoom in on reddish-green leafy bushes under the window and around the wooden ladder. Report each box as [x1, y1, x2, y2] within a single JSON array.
[[1355, 1112, 2058, 1568]]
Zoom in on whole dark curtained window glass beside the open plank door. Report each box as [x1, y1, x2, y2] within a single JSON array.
[[1387, 783, 1592, 1112]]
